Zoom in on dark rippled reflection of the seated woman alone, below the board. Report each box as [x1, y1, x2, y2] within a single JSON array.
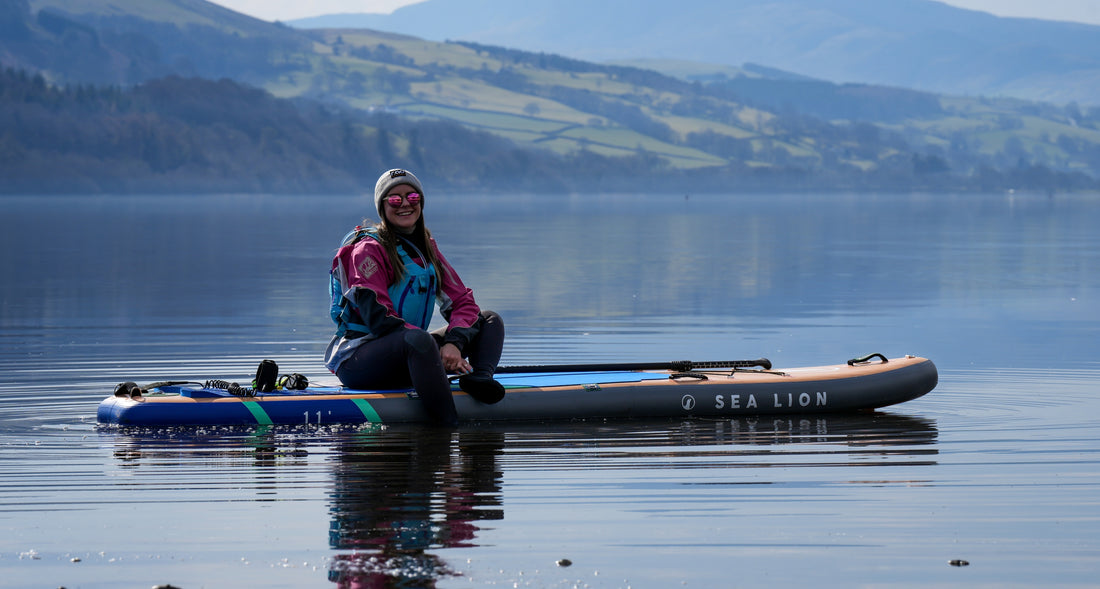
[[329, 428, 504, 589]]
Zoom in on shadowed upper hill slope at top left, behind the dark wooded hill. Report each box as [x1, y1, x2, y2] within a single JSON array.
[[10, 0, 311, 85]]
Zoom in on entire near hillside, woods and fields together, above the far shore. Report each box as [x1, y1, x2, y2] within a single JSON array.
[[0, 0, 1100, 192]]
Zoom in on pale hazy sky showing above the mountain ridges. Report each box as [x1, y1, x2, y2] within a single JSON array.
[[213, 0, 1100, 24]]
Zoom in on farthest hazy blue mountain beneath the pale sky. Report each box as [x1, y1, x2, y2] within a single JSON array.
[[290, 0, 1100, 105]]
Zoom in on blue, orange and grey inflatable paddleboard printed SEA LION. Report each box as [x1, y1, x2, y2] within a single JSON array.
[[98, 355, 938, 426]]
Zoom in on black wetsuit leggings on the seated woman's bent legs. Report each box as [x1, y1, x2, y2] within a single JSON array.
[[337, 310, 504, 425]]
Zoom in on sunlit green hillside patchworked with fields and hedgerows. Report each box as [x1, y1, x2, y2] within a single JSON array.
[[15, 0, 1100, 188]]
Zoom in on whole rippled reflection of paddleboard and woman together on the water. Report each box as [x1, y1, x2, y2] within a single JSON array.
[[100, 413, 939, 588]]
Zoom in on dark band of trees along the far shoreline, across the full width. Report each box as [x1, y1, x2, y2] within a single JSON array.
[[0, 69, 1097, 194]]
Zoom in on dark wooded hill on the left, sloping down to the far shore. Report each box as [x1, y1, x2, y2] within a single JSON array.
[[0, 69, 602, 195]]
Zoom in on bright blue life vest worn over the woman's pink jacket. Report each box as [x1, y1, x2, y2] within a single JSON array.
[[329, 228, 439, 337]]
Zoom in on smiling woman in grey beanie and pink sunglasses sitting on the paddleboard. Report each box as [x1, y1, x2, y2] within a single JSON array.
[[325, 170, 504, 425]]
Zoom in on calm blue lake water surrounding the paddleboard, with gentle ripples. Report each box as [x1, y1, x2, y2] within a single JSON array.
[[0, 194, 1100, 589]]
